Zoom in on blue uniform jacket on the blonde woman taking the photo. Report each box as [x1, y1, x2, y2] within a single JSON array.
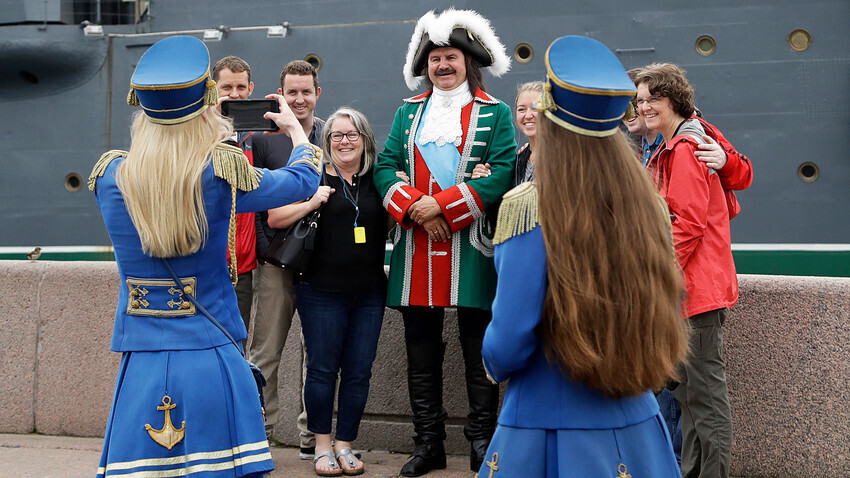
[[95, 143, 319, 352]]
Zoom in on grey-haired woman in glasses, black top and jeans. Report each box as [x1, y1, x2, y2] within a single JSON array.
[[269, 108, 387, 476]]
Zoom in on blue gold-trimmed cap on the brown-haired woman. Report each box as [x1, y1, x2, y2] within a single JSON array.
[[537, 35, 635, 137]]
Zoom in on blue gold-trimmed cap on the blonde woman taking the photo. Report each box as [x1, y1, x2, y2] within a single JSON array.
[[127, 36, 218, 124]]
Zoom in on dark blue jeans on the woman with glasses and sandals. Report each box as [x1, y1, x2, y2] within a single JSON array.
[[296, 283, 386, 441]]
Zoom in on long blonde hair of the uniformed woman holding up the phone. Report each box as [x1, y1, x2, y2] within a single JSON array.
[[116, 108, 232, 257]]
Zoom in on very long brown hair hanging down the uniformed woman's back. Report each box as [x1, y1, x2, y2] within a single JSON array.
[[536, 114, 688, 398]]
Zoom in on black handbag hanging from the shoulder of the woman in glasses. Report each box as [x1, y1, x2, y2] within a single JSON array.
[[260, 173, 325, 274]]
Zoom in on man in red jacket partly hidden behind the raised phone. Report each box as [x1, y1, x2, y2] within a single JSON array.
[[212, 56, 257, 347]]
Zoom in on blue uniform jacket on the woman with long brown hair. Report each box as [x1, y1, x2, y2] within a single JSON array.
[[481, 224, 658, 429]]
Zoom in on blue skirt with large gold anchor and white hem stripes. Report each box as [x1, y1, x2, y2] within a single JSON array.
[[97, 344, 274, 478]]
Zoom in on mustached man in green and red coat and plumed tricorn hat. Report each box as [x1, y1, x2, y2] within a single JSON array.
[[374, 9, 516, 476]]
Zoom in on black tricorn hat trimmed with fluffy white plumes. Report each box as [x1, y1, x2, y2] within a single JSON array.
[[404, 8, 511, 90]]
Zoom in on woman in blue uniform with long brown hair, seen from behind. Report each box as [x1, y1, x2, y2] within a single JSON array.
[[479, 36, 687, 478]]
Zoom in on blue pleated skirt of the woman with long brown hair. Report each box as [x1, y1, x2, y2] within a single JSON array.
[[478, 414, 682, 478]]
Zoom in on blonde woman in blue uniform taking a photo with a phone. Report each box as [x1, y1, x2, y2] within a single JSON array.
[[89, 36, 321, 477]]
